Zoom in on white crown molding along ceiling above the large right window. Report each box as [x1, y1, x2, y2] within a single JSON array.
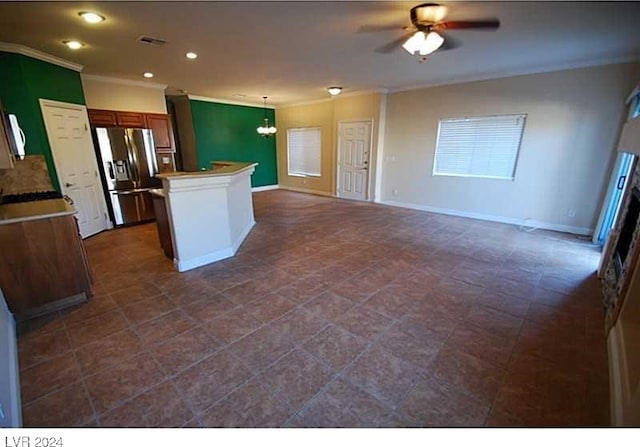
[[387, 56, 640, 93]]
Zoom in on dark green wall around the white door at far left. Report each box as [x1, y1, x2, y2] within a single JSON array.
[[0, 52, 85, 190]]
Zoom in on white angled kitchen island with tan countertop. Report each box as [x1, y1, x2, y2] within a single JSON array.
[[157, 161, 257, 272]]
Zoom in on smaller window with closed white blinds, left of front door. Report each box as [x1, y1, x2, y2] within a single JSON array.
[[287, 127, 322, 177]]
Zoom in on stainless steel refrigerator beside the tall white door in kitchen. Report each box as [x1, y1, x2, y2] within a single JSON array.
[[95, 127, 162, 225]]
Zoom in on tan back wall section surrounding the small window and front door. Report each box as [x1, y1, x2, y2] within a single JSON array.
[[276, 93, 381, 196]]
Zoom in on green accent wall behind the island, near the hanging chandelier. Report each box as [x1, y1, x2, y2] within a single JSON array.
[[190, 100, 278, 187]]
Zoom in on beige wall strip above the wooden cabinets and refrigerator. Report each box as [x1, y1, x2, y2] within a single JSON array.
[[81, 75, 167, 113]]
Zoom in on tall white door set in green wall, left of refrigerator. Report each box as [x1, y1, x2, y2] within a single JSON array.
[[40, 99, 109, 238]]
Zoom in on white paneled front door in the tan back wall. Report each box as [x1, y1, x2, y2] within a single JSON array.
[[337, 121, 371, 200]]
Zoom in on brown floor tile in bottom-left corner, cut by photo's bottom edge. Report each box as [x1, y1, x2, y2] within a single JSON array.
[[22, 382, 94, 428]]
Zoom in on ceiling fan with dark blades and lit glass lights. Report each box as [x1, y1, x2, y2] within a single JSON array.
[[358, 3, 500, 62]]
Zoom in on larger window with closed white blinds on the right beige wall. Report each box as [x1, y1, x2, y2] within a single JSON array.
[[433, 115, 526, 180]]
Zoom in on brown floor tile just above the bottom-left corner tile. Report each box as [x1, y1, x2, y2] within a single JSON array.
[[20, 351, 80, 405]]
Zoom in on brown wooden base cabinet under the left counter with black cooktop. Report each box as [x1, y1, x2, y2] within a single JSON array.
[[0, 208, 92, 321]]
